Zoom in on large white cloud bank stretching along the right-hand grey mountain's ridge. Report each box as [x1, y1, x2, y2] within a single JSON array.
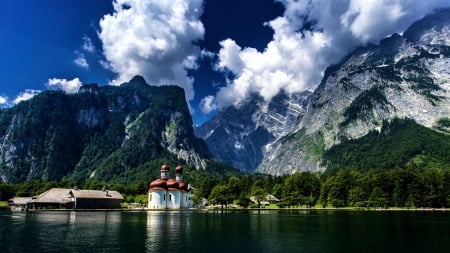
[[201, 0, 450, 111]]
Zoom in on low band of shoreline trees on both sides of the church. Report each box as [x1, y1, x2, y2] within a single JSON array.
[[0, 168, 450, 208]]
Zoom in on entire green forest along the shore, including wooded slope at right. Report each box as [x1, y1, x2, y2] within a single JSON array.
[[0, 119, 450, 208]]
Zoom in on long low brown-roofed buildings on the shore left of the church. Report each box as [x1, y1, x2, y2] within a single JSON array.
[[10, 188, 123, 209]]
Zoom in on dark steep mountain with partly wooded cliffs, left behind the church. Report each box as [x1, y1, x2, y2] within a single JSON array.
[[0, 76, 211, 182]]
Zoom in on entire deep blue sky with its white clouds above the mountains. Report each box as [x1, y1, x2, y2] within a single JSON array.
[[0, 0, 450, 124]]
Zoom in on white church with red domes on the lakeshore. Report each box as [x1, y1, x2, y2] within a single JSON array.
[[148, 164, 193, 209]]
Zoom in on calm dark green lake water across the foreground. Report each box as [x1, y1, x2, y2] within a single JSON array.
[[0, 210, 450, 253]]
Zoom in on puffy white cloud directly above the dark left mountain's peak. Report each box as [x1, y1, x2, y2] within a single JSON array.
[[98, 0, 205, 101]]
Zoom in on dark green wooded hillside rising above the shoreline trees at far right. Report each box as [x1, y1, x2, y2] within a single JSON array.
[[324, 119, 450, 172]]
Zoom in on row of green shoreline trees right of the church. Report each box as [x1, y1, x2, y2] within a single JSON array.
[[202, 168, 450, 208]]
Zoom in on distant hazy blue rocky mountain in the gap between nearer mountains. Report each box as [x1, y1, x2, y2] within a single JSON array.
[[195, 92, 311, 172]]
